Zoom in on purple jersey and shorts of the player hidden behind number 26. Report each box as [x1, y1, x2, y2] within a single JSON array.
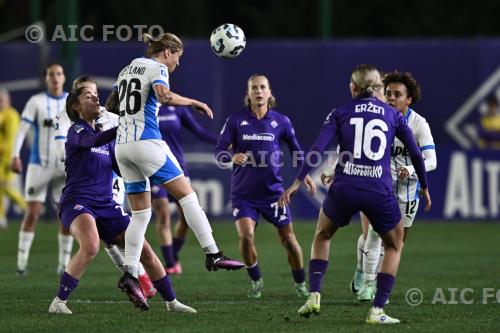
[[151, 105, 217, 201]]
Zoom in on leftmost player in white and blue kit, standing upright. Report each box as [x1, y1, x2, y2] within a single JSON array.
[[11, 63, 73, 276]]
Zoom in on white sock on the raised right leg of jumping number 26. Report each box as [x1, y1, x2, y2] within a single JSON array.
[[179, 192, 219, 253]]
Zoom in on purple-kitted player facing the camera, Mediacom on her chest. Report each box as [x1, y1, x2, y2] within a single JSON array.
[[215, 75, 316, 298]]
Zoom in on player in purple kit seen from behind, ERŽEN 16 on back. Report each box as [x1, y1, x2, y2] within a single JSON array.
[[280, 65, 431, 324]]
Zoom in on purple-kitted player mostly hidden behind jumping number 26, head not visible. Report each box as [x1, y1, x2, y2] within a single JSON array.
[[151, 105, 217, 274]]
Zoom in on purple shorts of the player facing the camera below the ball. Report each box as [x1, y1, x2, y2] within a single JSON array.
[[232, 197, 292, 228]]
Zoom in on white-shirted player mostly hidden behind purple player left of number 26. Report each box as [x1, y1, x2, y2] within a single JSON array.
[[54, 75, 156, 298]]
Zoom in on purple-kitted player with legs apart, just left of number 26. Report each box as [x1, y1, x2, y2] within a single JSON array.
[[49, 86, 196, 314]]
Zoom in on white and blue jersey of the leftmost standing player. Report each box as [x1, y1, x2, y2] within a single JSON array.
[[21, 92, 68, 168]]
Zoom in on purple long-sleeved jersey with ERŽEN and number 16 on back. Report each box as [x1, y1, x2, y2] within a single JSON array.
[[297, 96, 427, 193]]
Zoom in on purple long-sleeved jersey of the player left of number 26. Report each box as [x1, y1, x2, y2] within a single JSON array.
[[61, 120, 119, 205]]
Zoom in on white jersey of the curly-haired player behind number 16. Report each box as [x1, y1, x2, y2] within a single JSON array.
[[391, 109, 436, 202]]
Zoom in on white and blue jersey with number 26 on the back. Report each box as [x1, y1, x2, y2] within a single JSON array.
[[116, 58, 170, 145]]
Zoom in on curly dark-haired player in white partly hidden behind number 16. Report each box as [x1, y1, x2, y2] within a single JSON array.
[[344, 72, 437, 301]]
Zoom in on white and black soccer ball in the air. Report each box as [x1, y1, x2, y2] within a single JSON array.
[[210, 23, 247, 58]]
